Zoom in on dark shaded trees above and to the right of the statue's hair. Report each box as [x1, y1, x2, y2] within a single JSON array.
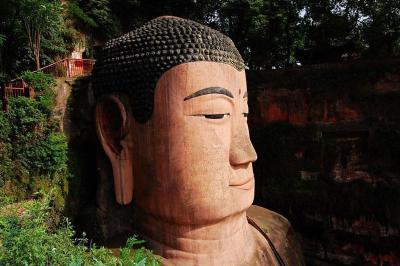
[[72, 0, 400, 69]]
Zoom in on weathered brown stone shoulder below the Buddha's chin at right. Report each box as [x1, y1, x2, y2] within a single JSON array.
[[247, 205, 305, 266]]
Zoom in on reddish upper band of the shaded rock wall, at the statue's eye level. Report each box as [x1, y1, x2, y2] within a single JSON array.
[[250, 68, 400, 126]]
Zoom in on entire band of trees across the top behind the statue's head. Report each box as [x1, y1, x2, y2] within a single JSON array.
[[0, 0, 400, 74]]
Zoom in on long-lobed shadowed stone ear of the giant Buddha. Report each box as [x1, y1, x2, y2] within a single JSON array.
[[95, 96, 134, 205]]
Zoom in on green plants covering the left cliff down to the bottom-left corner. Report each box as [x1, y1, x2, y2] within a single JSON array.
[[0, 72, 159, 266]]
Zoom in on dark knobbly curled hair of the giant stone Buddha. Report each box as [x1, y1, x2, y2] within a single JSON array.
[[93, 17, 244, 123]]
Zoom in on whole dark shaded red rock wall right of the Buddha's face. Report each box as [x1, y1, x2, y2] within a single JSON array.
[[249, 62, 400, 266]]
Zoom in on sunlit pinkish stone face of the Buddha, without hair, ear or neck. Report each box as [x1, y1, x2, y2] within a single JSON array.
[[133, 62, 256, 224]]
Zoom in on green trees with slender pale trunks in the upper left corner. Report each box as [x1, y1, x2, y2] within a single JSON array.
[[0, 0, 75, 77]]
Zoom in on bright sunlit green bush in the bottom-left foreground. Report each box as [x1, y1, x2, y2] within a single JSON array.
[[0, 195, 159, 266]]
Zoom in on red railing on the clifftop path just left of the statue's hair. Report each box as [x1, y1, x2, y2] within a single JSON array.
[[34, 58, 96, 78]]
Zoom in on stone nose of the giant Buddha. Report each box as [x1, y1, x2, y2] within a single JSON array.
[[229, 121, 257, 165]]
